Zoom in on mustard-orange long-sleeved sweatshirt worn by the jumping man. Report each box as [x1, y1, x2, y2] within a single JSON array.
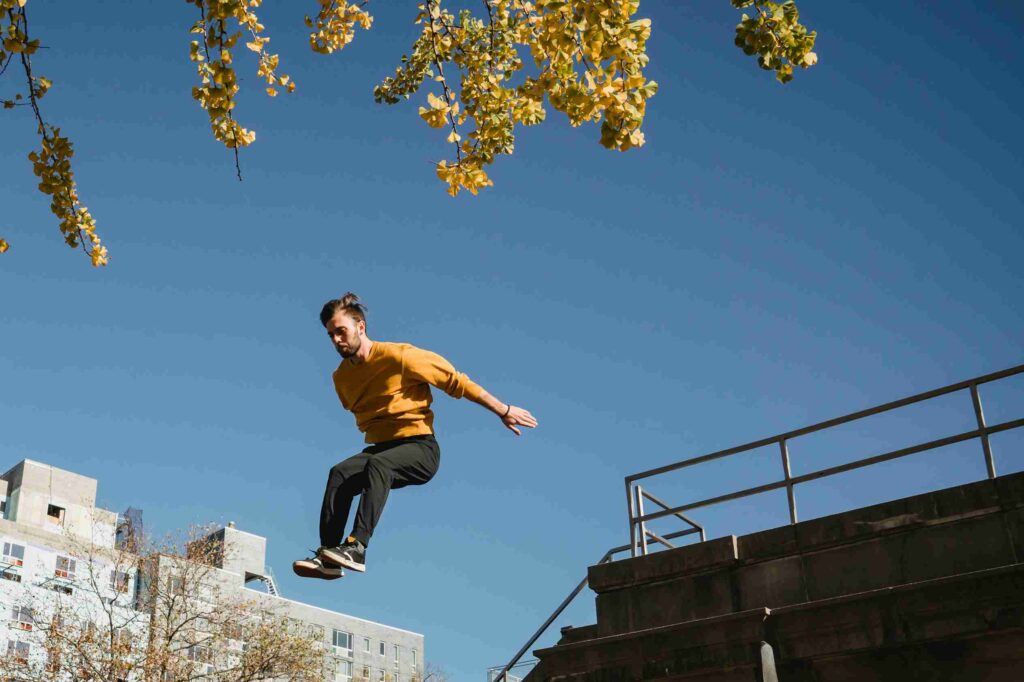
[[334, 341, 483, 442]]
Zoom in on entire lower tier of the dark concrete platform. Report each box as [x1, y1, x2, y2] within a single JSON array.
[[528, 563, 1024, 682]]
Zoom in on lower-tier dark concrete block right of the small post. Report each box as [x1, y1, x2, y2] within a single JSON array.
[[767, 563, 1024, 682]]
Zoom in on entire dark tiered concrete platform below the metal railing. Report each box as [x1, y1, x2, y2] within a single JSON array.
[[527, 473, 1024, 682]]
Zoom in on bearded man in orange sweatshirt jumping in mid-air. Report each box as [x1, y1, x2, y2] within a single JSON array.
[[292, 293, 537, 580]]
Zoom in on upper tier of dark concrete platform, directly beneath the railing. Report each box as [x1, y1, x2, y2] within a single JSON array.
[[589, 473, 1024, 634]]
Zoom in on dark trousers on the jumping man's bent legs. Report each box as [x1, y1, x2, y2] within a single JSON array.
[[321, 435, 441, 547]]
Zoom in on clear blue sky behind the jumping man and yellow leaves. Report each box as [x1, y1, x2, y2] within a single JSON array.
[[0, 0, 1024, 680]]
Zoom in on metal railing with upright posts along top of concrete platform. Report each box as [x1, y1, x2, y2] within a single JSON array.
[[626, 365, 1024, 557]]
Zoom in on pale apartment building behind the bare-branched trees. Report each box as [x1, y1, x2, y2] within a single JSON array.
[[0, 460, 424, 682]]
